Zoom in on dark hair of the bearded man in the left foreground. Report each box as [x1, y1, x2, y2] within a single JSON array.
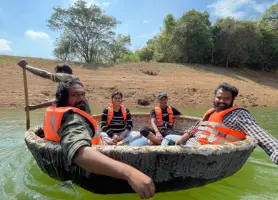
[[56, 78, 83, 107]]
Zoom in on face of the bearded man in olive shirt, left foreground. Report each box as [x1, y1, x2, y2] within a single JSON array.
[[68, 84, 88, 111]]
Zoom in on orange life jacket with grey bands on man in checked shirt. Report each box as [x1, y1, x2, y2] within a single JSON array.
[[196, 106, 246, 144]]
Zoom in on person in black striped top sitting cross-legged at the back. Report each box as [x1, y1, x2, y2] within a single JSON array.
[[100, 91, 141, 145]]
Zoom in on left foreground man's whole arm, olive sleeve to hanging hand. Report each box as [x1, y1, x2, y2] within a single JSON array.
[[58, 111, 155, 198]]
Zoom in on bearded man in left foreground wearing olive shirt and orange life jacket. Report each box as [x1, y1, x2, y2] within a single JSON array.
[[44, 79, 155, 198]]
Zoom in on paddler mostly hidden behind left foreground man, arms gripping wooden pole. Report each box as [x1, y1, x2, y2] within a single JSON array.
[[17, 60, 79, 110]]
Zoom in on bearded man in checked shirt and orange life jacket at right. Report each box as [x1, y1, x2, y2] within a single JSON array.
[[162, 83, 278, 164]]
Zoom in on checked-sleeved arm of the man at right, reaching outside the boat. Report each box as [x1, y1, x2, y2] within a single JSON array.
[[236, 110, 278, 165]]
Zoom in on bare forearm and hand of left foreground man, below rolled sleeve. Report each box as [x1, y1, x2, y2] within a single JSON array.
[[73, 146, 155, 198]]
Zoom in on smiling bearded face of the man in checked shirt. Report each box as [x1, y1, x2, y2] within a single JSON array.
[[213, 89, 234, 111]]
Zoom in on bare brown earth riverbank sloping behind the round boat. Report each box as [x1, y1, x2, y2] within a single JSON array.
[[0, 56, 278, 108]]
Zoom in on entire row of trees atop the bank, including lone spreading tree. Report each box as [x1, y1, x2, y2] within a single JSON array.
[[48, 0, 278, 71]]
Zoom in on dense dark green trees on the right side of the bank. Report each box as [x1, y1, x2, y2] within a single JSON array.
[[138, 4, 278, 71]]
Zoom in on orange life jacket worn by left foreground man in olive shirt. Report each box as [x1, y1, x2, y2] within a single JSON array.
[[43, 106, 104, 145]]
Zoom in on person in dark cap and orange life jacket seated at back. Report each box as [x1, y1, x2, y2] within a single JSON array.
[[132, 93, 182, 146]]
